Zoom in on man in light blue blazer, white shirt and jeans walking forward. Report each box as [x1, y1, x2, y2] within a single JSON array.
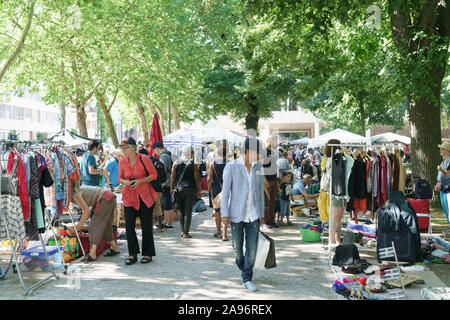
[[220, 138, 264, 291]]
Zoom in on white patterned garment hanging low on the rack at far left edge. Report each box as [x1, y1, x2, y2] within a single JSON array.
[[0, 194, 26, 241]]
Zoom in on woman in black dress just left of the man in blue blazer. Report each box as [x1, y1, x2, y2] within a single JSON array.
[[208, 146, 228, 241]]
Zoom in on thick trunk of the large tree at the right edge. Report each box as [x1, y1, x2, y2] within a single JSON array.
[[388, 0, 450, 198]]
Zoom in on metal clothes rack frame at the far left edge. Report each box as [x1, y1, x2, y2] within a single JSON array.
[[0, 159, 59, 295]]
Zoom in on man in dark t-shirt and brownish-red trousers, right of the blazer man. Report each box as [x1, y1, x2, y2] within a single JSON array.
[[263, 136, 280, 228]]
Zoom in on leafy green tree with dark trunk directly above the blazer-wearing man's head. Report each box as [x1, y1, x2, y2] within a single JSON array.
[[199, 11, 296, 132]]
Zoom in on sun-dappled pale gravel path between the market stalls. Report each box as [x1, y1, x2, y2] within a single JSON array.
[[0, 202, 445, 300]]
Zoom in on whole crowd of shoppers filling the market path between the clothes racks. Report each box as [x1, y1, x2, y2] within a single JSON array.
[[66, 136, 450, 291]]
